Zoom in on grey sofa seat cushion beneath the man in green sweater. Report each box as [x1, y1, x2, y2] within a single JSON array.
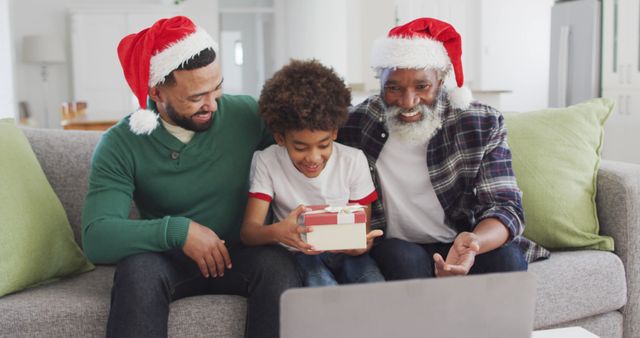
[[0, 266, 246, 337]]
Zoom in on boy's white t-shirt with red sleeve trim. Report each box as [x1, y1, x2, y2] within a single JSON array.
[[249, 142, 378, 220]]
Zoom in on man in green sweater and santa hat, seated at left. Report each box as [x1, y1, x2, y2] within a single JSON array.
[[83, 17, 301, 337]]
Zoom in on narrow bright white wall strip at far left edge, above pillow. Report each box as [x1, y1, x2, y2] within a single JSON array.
[[0, 0, 17, 118]]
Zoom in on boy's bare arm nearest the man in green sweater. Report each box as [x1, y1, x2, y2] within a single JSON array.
[[240, 197, 313, 252]]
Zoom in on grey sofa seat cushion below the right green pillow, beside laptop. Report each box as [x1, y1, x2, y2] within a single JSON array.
[[529, 250, 627, 327]]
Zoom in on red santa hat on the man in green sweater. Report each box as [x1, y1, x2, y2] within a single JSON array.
[[118, 16, 218, 134]]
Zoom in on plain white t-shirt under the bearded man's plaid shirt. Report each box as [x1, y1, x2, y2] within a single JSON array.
[[376, 135, 457, 244]]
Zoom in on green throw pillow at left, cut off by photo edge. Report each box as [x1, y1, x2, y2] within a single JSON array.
[[0, 119, 94, 297]]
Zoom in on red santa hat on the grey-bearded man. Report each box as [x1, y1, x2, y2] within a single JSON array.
[[371, 18, 472, 109]]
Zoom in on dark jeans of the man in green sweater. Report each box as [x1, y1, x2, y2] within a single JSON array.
[[107, 245, 302, 338]]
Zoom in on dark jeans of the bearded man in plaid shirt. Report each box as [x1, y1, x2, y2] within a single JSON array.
[[371, 238, 528, 280]]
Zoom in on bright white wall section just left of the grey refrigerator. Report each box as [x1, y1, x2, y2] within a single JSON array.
[[476, 0, 553, 111]]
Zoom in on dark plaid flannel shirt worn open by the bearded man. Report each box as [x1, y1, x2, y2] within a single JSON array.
[[338, 90, 550, 262]]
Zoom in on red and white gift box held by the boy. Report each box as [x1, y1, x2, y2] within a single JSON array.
[[298, 204, 367, 251]]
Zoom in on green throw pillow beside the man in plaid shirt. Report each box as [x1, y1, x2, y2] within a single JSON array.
[[505, 99, 613, 250]]
